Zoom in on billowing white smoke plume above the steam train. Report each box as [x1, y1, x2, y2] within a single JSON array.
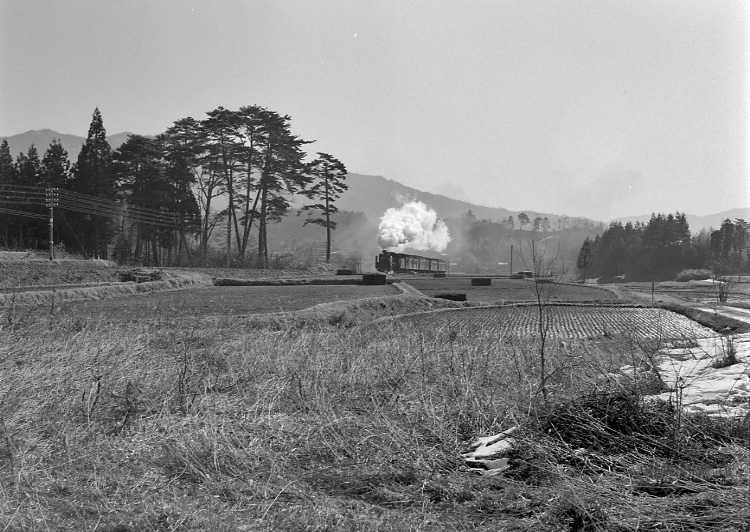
[[378, 201, 451, 251]]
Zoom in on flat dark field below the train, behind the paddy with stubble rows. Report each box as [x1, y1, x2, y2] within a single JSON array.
[[402, 277, 618, 303]]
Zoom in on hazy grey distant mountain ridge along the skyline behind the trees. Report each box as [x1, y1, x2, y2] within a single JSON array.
[[2, 129, 750, 232]]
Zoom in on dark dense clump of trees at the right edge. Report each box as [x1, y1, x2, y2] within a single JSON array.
[[577, 212, 750, 281]]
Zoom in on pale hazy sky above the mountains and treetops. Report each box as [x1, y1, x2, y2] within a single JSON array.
[[0, 0, 750, 220]]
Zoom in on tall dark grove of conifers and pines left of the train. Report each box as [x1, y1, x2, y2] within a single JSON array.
[[0, 105, 347, 267]]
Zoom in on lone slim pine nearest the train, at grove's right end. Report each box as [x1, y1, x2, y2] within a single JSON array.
[[300, 152, 349, 264]]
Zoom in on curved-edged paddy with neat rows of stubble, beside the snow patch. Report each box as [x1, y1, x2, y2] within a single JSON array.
[[402, 305, 715, 340]]
